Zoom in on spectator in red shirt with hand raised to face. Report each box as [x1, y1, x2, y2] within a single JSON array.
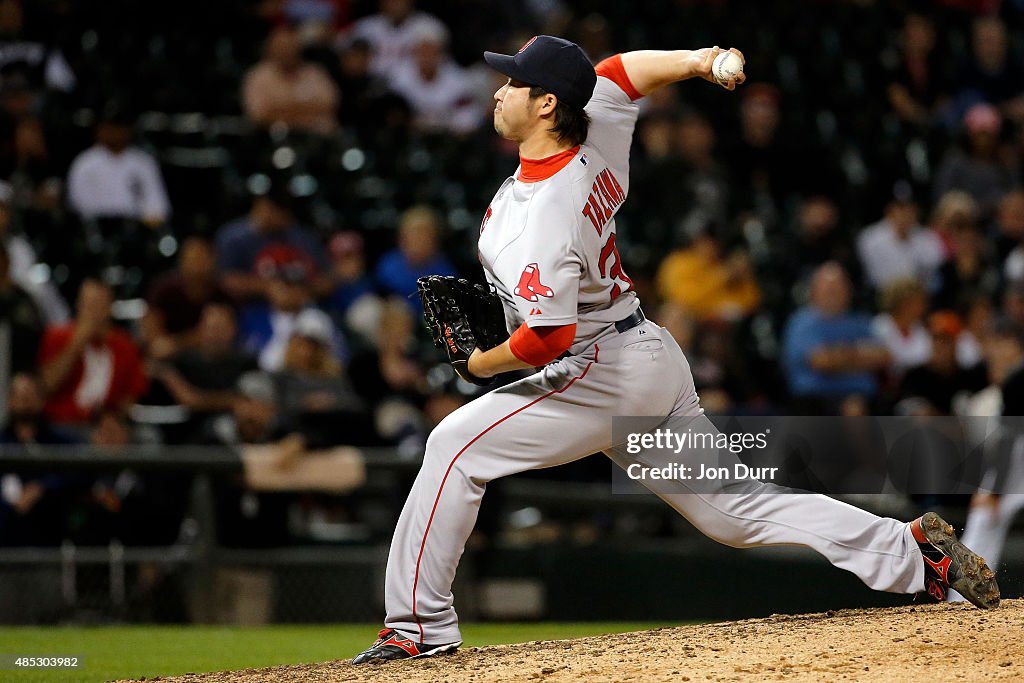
[[39, 280, 148, 424]]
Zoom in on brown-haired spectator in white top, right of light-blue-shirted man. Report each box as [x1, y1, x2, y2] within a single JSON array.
[[871, 280, 932, 378]]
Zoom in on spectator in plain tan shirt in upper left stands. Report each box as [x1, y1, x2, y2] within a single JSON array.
[[242, 25, 339, 135]]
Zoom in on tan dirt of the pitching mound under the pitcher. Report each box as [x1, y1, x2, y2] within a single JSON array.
[[132, 599, 1024, 683]]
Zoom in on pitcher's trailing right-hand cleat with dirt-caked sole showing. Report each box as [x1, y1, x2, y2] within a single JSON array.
[[910, 512, 999, 609]]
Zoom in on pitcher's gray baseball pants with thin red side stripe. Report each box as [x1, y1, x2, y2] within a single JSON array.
[[385, 321, 925, 644]]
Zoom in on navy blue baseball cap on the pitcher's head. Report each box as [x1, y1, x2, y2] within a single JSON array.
[[483, 36, 597, 109]]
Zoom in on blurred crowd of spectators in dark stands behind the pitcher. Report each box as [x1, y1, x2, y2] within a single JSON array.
[[0, 0, 1024, 545]]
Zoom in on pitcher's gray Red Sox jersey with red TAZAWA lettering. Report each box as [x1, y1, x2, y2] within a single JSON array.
[[478, 78, 640, 352]]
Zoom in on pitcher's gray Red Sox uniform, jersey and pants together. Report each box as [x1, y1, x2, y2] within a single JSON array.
[[385, 56, 924, 644]]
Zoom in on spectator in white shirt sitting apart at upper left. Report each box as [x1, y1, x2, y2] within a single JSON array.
[[68, 103, 171, 226]]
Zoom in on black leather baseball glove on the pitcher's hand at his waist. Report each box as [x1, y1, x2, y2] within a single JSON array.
[[416, 275, 508, 386]]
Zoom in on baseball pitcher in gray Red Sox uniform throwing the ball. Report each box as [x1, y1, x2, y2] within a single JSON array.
[[352, 36, 999, 664]]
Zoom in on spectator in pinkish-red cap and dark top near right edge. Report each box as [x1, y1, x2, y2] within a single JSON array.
[[932, 102, 1016, 219]]
